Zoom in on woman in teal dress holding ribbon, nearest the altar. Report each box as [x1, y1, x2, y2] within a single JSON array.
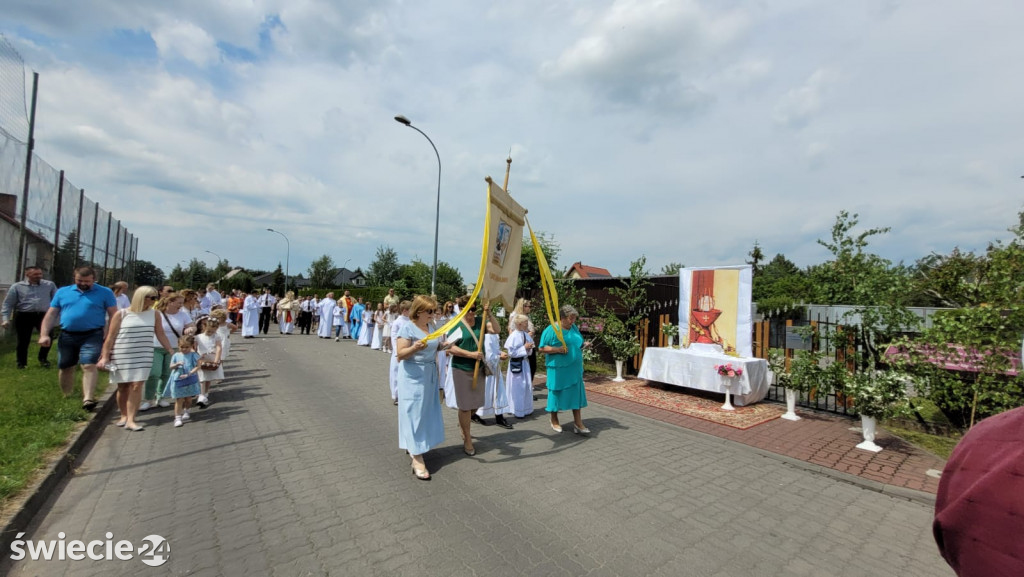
[[539, 304, 590, 435]]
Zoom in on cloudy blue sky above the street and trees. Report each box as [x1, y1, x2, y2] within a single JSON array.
[[0, 0, 1024, 282]]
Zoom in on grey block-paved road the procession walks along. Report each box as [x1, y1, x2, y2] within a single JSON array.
[[0, 335, 952, 577]]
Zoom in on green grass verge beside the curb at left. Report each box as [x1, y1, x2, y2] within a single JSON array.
[[0, 336, 106, 508]]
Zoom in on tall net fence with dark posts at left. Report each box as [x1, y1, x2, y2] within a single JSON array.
[[0, 35, 138, 286]]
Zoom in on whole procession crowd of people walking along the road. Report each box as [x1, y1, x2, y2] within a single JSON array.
[[3, 266, 590, 480]]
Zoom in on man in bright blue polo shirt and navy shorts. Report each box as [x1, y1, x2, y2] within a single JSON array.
[[39, 266, 118, 411]]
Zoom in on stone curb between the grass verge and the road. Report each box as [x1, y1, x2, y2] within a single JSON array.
[[0, 385, 118, 557]]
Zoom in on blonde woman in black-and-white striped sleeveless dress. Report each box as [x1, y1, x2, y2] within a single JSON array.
[[96, 286, 174, 430]]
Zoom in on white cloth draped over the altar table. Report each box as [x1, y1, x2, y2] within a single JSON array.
[[638, 346, 771, 407]]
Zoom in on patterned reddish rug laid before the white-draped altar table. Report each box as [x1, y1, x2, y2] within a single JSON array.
[[586, 377, 785, 429]]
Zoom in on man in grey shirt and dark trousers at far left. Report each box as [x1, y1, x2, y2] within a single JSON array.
[[2, 266, 57, 369]]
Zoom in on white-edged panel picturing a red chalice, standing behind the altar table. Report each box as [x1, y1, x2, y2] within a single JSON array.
[[679, 264, 754, 358]]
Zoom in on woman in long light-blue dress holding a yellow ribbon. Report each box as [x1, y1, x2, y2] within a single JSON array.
[[395, 295, 444, 481]]
